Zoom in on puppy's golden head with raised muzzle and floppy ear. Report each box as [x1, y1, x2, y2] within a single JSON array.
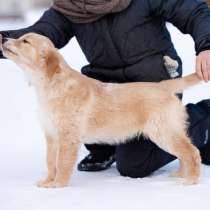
[[2, 33, 59, 77]]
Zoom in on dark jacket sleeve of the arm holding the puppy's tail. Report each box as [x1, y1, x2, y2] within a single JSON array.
[[148, 0, 210, 54]]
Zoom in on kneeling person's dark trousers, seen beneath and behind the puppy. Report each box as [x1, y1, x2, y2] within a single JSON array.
[[86, 104, 210, 178]]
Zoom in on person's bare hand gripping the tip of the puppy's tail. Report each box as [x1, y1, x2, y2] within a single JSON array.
[[196, 50, 210, 82]]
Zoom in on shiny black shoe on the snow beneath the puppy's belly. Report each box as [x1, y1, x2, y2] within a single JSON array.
[[77, 154, 115, 171]]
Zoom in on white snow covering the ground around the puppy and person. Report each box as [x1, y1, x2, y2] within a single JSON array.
[[0, 8, 210, 210]]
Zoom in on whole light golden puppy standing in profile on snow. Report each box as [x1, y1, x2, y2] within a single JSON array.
[[3, 33, 201, 187]]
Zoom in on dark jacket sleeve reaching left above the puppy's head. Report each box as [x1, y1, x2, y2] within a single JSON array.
[[0, 8, 74, 57]]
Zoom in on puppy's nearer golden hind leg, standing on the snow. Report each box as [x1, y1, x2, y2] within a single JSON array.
[[148, 130, 201, 184]]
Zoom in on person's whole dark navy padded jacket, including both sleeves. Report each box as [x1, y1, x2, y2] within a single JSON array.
[[0, 0, 210, 82]]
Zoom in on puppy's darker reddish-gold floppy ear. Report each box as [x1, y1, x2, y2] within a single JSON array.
[[43, 50, 60, 79]]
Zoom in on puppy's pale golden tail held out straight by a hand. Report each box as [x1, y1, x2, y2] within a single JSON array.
[[159, 73, 201, 93]]
